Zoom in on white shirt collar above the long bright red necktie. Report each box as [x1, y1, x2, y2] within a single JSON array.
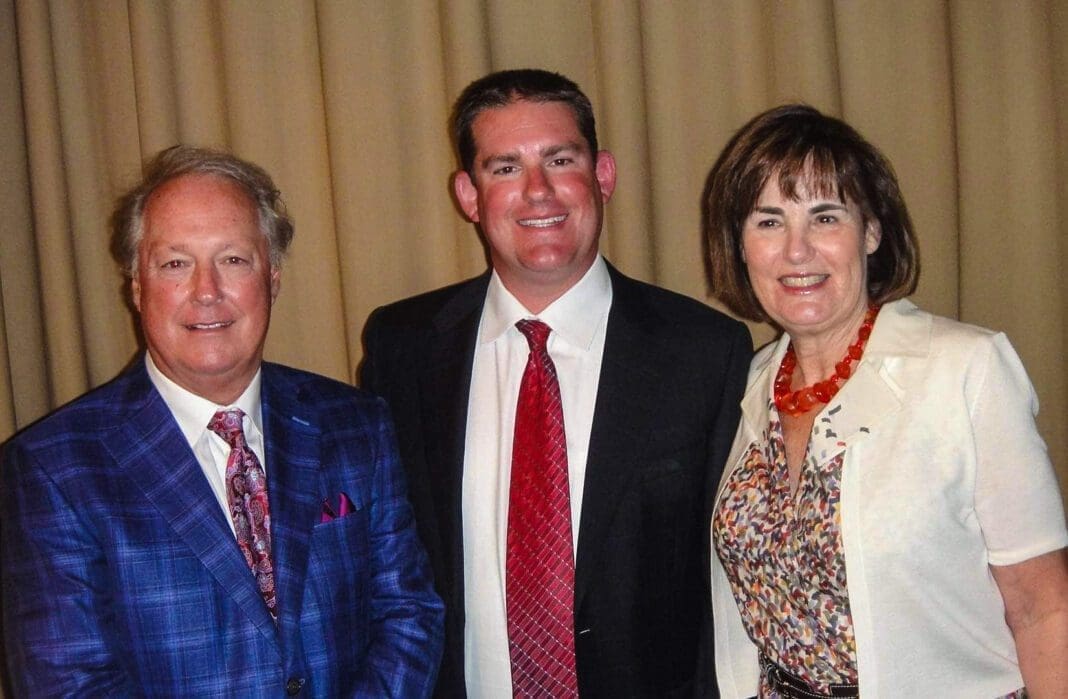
[[478, 255, 612, 350]]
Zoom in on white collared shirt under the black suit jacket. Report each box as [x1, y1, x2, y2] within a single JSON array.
[[461, 255, 612, 699]]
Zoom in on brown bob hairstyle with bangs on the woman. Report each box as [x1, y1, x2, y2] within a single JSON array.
[[702, 105, 920, 322]]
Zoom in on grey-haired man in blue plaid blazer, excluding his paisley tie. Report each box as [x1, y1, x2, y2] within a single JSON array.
[[0, 146, 443, 697]]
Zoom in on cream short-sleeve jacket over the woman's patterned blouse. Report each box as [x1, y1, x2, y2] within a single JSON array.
[[712, 300, 1068, 699]]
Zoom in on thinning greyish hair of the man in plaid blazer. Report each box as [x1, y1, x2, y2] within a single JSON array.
[[111, 144, 293, 279]]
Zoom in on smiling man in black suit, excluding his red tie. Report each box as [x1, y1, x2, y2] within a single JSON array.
[[361, 69, 752, 697]]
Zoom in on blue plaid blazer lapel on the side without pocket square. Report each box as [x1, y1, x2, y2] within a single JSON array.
[[103, 364, 277, 640]]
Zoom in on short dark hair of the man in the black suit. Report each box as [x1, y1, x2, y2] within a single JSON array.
[[452, 68, 597, 177]]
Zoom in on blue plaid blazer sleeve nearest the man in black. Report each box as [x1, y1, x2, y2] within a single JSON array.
[[354, 401, 444, 697]]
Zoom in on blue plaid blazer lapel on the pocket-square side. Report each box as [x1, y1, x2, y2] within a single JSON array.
[[261, 363, 323, 637]]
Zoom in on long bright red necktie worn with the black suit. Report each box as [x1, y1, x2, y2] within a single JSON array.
[[505, 321, 579, 698]]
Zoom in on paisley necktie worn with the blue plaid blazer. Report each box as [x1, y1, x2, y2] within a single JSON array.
[[207, 408, 278, 619]]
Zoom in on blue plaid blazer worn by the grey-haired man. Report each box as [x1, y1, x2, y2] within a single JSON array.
[[0, 361, 443, 697]]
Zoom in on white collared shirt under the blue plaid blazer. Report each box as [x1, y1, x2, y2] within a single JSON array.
[[144, 352, 267, 537]]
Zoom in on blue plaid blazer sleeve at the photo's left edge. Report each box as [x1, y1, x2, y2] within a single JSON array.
[[0, 442, 135, 697]]
